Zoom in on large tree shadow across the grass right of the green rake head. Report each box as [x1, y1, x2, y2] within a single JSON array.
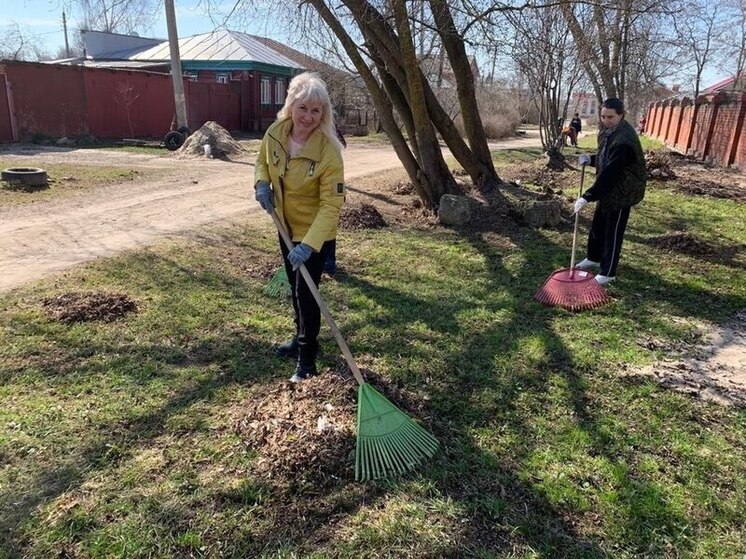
[[314, 218, 741, 557]]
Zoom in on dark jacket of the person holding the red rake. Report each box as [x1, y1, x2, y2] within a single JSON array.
[[583, 119, 648, 212]]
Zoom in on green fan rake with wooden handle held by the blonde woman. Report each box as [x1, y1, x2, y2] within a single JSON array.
[[272, 211, 438, 481]]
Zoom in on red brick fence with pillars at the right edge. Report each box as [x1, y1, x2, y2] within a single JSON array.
[[645, 93, 746, 170]]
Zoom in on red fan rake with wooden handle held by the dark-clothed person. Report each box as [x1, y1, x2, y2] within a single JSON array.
[[534, 165, 611, 311]]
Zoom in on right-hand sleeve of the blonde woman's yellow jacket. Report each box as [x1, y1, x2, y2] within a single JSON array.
[[303, 144, 345, 252]]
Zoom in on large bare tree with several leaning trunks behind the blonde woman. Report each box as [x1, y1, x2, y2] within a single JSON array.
[[201, 0, 501, 209]]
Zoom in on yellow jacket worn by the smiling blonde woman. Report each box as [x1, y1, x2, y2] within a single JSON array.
[[254, 118, 345, 252]]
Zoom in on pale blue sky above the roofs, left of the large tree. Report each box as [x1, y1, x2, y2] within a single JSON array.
[[0, 0, 281, 55]]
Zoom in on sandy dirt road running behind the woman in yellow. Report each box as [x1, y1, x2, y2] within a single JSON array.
[[0, 134, 539, 292]]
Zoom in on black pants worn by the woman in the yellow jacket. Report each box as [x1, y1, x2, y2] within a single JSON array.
[[280, 238, 331, 356]]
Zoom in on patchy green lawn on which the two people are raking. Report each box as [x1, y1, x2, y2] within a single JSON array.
[[0, 150, 746, 559]]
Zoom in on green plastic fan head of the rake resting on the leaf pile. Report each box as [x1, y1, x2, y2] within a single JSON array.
[[355, 383, 438, 481]]
